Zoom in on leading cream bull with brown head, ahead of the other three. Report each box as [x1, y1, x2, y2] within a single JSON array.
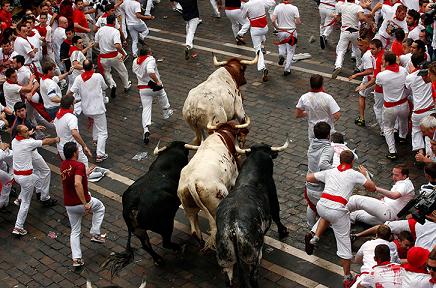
[[183, 55, 258, 145]]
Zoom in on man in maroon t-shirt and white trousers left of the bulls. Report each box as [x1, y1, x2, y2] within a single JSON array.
[[57, 142, 106, 267]]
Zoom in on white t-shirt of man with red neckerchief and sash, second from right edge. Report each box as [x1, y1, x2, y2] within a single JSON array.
[[375, 66, 407, 102]]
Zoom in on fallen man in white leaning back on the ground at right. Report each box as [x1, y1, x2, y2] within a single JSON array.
[[347, 165, 415, 225]]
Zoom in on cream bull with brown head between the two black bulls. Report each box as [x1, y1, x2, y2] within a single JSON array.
[[177, 119, 250, 248]]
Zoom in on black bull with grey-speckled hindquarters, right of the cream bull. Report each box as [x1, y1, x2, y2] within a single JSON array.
[[216, 139, 289, 287]]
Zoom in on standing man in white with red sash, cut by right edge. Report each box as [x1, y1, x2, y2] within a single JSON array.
[[405, 53, 435, 153]]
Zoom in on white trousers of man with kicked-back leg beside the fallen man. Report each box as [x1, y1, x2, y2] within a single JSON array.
[[312, 202, 353, 259]]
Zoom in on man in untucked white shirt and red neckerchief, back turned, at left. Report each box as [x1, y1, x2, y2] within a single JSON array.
[[67, 60, 108, 163]]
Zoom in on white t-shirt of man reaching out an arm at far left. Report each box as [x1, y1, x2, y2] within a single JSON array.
[[12, 138, 42, 171]]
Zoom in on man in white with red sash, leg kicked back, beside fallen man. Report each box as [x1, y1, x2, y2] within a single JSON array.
[[305, 150, 375, 287]]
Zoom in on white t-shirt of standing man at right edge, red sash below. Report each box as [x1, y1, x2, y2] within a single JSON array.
[[405, 70, 434, 111]]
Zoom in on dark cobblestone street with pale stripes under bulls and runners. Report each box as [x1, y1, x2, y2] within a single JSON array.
[[0, 0, 430, 288]]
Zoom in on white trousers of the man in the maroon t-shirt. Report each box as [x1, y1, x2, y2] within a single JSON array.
[[65, 197, 105, 259]]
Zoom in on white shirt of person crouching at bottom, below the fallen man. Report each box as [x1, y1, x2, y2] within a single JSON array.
[[355, 238, 400, 273]]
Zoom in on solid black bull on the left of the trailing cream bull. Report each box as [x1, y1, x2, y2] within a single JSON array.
[[102, 141, 198, 275]]
